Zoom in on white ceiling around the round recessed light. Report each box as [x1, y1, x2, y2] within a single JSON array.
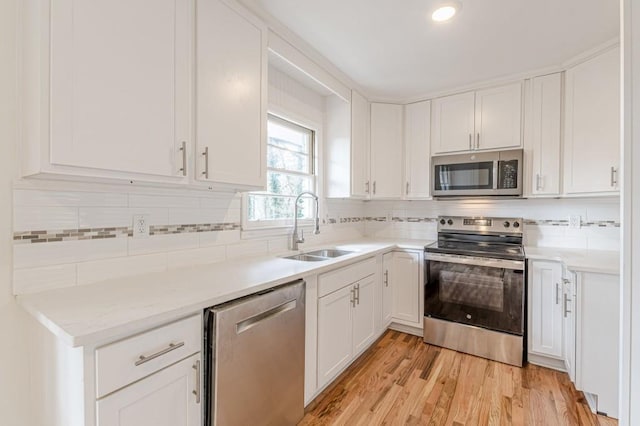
[[253, 0, 619, 100]]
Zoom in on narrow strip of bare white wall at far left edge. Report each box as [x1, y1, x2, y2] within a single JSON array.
[[0, 0, 29, 426]]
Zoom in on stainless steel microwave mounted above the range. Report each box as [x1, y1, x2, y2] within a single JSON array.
[[431, 149, 523, 197]]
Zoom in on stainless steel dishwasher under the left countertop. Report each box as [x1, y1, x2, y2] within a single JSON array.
[[205, 280, 305, 426]]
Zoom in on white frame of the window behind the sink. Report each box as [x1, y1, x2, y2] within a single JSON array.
[[241, 112, 320, 233]]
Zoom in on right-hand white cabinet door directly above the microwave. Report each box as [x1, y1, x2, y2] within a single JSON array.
[[474, 83, 522, 149]]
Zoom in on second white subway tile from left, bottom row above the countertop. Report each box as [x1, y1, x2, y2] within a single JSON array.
[[78, 253, 167, 285]]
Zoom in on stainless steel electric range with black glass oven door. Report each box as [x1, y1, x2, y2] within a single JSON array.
[[424, 217, 526, 366]]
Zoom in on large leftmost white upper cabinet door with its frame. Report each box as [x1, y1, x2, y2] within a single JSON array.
[[21, 0, 193, 183]]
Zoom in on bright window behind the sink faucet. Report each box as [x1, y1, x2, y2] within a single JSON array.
[[246, 115, 316, 228]]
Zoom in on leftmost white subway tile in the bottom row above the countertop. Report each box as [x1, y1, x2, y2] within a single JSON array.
[[13, 263, 77, 294]]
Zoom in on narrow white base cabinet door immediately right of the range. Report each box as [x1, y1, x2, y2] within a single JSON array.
[[529, 261, 563, 358]]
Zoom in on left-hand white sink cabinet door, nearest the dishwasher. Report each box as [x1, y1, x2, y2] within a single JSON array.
[[318, 286, 353, 388]]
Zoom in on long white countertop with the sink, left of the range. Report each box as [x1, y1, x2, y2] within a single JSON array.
[[17, 239, 432, 347]]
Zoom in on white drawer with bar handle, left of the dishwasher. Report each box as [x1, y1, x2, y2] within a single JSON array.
[[96, 315, 202, 398]]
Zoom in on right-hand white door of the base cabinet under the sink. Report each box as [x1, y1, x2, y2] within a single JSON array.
[[353, 275, 376, 355]]
